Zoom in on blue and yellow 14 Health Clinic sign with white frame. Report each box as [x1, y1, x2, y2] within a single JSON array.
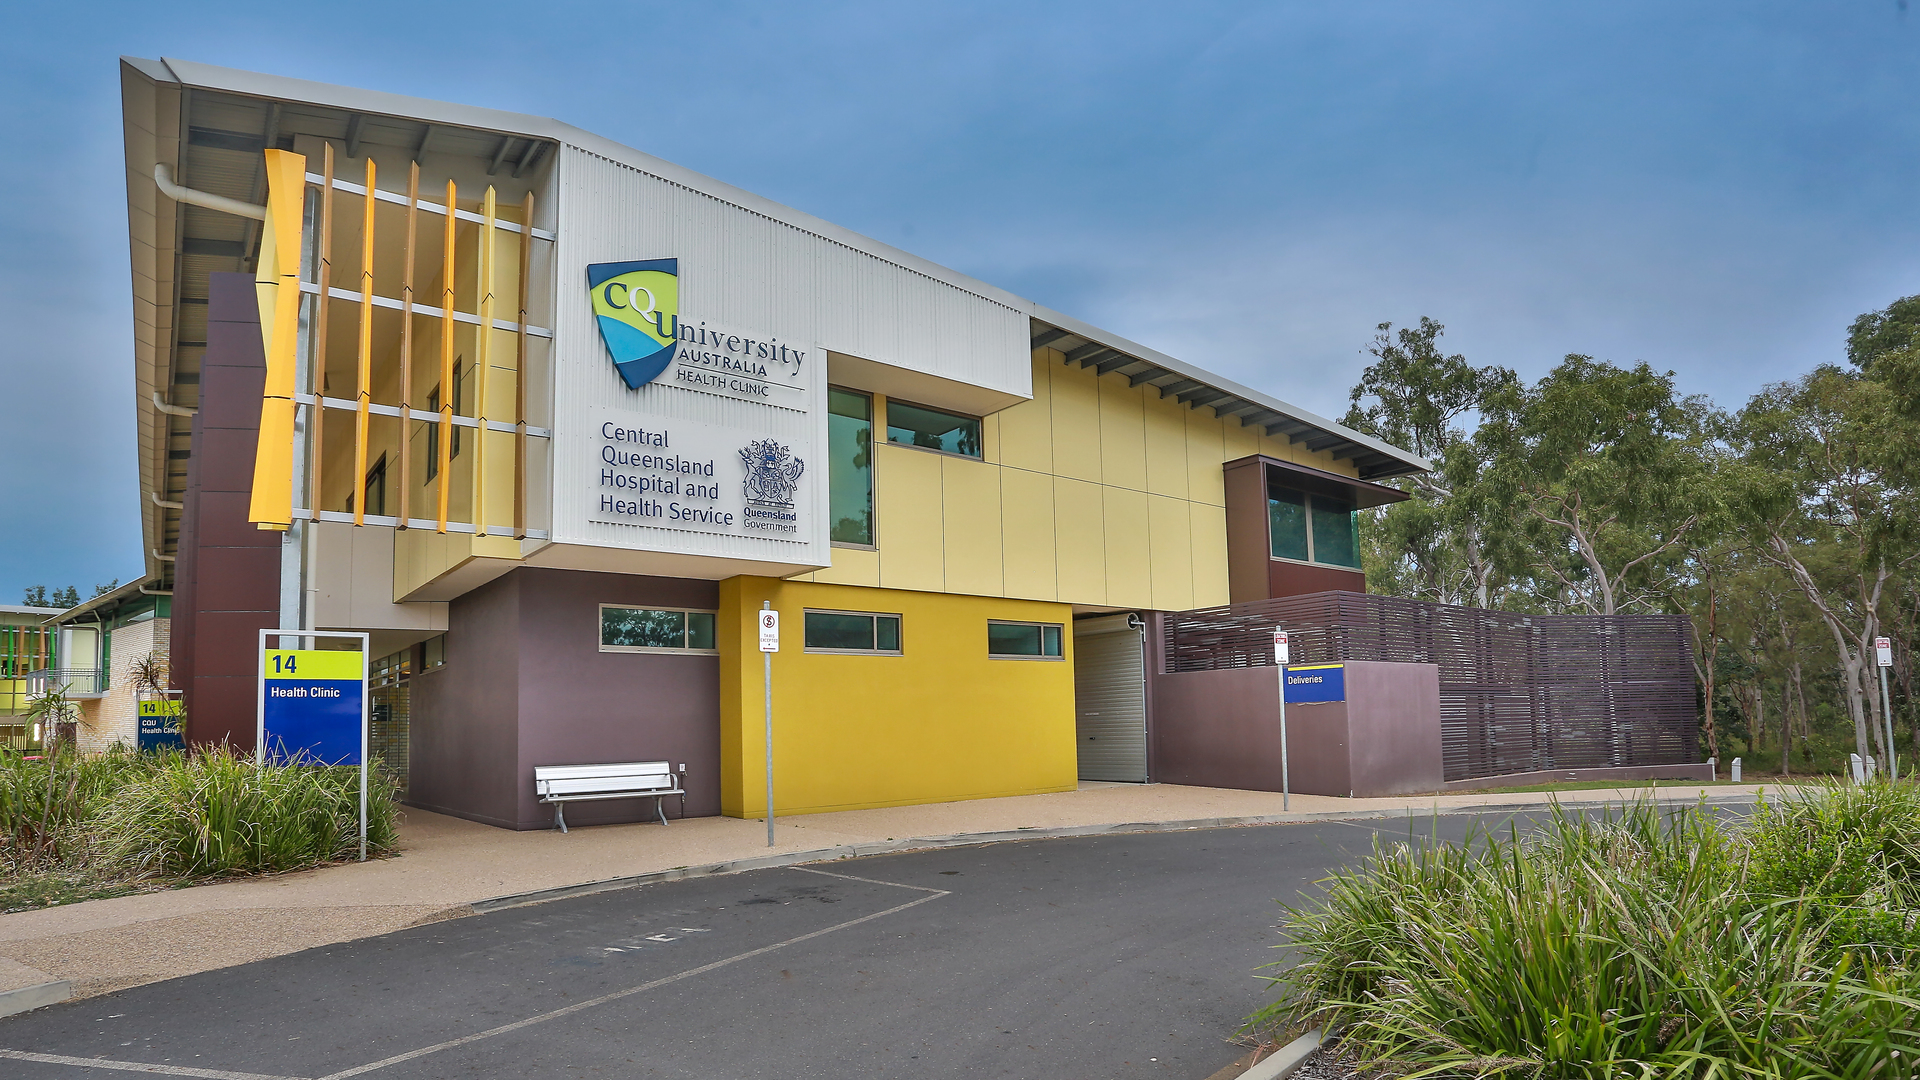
[[253, 630, 372, 863]]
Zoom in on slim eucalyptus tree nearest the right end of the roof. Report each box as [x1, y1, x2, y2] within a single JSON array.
[[1342, 315, 1517, 607]]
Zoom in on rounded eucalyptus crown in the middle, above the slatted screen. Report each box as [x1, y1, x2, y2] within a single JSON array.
[[1475, 356, 1713, 615]]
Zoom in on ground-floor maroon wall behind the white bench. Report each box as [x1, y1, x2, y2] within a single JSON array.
[[407, 567, 720, 828]]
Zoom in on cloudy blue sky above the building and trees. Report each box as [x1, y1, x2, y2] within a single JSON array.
[[0, 0, 1920, 601]]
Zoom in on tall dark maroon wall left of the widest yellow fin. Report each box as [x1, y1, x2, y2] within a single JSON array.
[[169, 273, 284, 749]]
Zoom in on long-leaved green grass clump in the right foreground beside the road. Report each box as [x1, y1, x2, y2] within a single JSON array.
[[1250, 784, 1920, 1080]]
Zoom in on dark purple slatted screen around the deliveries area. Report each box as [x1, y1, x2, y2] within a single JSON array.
[[1165, 592, 1699, 780]]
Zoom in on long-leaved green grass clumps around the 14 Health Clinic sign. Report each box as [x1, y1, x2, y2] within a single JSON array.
[[0, 748, 399, 884]]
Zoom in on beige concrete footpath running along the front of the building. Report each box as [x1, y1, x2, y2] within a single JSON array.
[[0, 772, 1766, 997]]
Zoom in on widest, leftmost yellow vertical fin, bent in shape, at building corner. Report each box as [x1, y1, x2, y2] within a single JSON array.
[[248, 150, 307, 530]]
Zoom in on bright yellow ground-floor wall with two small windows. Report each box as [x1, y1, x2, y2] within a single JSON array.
[[716, 578, 1077, 817]]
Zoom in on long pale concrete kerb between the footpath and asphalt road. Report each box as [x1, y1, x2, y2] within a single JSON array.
[[470, 794, 1757, 915]]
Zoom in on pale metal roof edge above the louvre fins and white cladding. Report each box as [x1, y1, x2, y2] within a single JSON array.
[[151, 58, 1033, 315]]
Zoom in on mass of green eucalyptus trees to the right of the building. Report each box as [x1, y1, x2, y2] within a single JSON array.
[[1346, 296, 1920, 771]]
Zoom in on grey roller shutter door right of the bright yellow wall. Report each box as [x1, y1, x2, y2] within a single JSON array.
[[1073, 615, 1146, 784]]
